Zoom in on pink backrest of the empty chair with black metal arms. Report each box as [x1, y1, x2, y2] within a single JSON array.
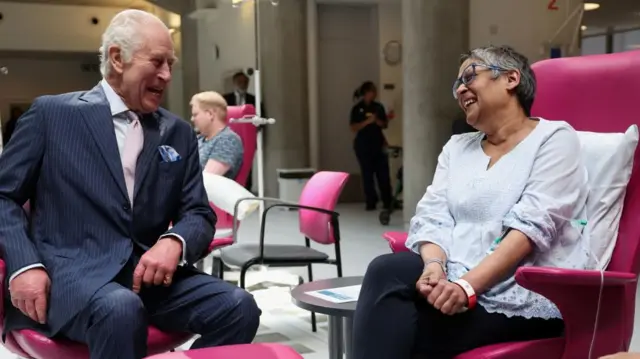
[[299, 172, 349, 244]]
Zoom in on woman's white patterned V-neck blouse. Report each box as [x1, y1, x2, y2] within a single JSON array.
[[407, 119, 594, 319]]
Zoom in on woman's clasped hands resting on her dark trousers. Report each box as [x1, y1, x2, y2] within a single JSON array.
[[416, 263, 468, 315]]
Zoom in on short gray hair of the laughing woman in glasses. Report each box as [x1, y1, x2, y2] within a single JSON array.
[[460, 45, 536, 116]]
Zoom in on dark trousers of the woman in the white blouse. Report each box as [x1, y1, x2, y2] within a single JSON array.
[[353, 252, 564, 359]]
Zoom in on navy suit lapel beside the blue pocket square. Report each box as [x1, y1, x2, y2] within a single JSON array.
[[133, 112, 165, 203]]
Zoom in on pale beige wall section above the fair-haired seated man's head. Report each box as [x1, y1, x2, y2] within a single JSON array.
[[198, 1, 256, 92]]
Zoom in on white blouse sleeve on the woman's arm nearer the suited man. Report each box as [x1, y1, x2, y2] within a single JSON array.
[[406, 137, 455, 257]]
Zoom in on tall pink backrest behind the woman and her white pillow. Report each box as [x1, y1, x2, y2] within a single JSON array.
[[532, 51, 640, 339]]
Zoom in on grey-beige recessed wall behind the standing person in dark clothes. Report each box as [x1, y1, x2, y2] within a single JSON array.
[[318, 4, 380, 173]]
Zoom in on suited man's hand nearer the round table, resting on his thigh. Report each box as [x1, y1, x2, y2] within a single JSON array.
[[132, 237, 182, 293]]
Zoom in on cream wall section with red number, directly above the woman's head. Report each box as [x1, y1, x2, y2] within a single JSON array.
[[469, 0, 584, 62]]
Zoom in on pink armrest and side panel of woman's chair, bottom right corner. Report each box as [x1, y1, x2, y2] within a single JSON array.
[[516, 267, 637, 358]]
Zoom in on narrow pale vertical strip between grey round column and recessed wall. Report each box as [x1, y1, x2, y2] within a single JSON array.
[[307, 0, 320, 169]]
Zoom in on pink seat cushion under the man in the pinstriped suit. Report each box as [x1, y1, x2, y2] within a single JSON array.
[[12, 327, 192, 359]]
